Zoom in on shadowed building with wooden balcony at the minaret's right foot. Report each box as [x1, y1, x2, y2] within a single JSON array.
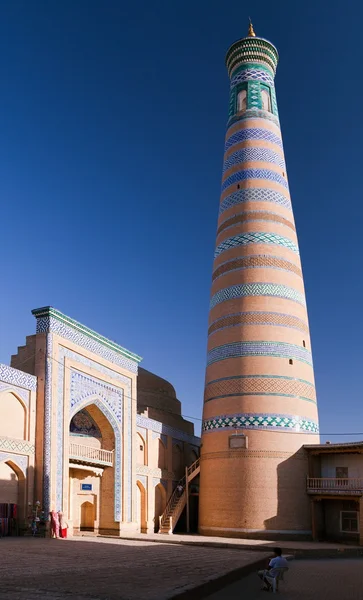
[[305, 442, 363, 545]]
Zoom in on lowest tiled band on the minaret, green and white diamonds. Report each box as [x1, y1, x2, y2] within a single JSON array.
[[202, 413, 319, 433]]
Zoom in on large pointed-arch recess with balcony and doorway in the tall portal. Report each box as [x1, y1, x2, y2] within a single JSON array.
[[69, 400, 115, 534]]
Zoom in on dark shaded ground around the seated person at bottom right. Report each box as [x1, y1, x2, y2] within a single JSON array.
[[208, 558, 363, 600]]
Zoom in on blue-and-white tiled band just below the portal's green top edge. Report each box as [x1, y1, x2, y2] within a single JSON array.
[[37, 317, 137, 373]]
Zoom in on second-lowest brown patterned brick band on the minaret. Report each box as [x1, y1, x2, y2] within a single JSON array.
[[208, 311, 309, 335]]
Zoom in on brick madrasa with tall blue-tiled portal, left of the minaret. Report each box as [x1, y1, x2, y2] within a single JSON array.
[[0, 307, 200, 535]]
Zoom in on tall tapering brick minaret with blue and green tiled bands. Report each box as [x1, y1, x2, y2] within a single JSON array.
[[199, 24, 319, 538]]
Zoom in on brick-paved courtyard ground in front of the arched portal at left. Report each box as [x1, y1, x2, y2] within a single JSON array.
[[0, 537, 270, 600]]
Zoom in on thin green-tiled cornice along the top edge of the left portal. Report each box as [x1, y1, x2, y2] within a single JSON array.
[[32, 306, 142, 363]]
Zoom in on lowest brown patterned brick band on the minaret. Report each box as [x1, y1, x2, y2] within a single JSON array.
[[204, 375, 316, 402]]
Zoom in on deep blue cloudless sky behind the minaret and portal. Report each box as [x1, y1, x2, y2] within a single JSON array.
[[0, 0, 363, 440]]
